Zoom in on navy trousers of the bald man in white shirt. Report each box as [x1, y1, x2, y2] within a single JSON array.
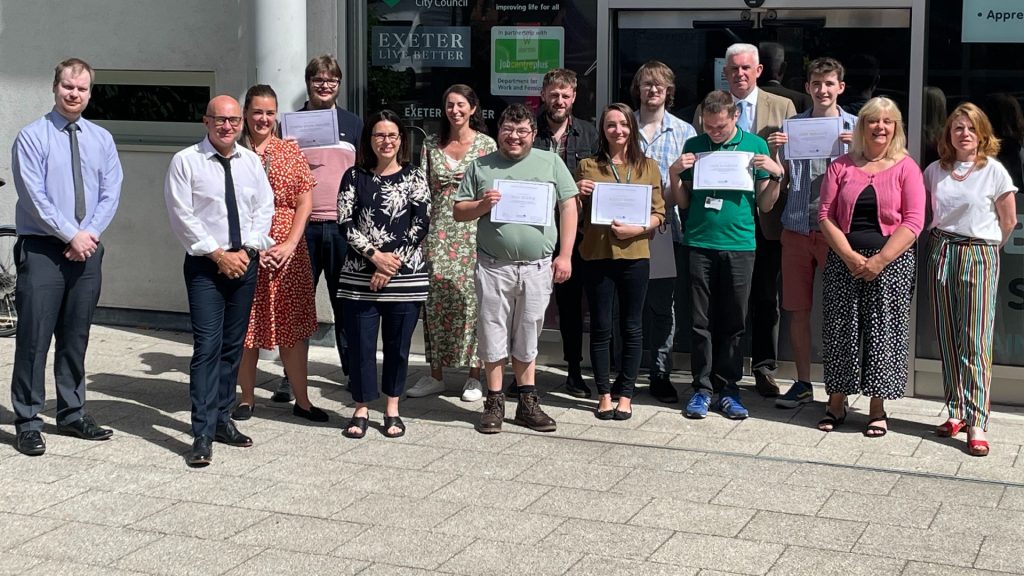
[[183, 255, 259, 438]]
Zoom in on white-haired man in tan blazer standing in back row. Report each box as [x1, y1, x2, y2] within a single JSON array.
[[693, 44, 797, 398]]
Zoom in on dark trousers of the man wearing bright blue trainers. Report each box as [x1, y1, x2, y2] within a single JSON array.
[[690, 246, 755, 398]]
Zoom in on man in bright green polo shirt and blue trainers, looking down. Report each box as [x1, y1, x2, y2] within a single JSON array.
[[669, 90, 783, 420]]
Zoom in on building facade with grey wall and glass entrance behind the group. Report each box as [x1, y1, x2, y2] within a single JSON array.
[[0, 0, 1024, 403]]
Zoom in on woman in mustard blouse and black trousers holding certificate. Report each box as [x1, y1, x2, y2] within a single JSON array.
[[577, 104, 665, 420]]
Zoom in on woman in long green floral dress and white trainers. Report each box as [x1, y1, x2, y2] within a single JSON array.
[[406, 84, 497, 402]]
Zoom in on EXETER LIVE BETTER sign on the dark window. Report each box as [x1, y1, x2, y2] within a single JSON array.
[[370, 26, 470, 68]]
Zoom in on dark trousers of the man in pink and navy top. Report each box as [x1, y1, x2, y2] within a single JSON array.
[[306, 220, 348, 374]]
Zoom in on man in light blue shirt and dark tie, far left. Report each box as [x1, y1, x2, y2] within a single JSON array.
[[11, 58, 122, 456]]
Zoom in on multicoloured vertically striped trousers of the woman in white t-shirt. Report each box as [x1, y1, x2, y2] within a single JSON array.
[[927, 229, 999, 428]]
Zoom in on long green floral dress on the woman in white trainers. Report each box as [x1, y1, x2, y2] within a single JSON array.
[[423, 132, 498, 369]]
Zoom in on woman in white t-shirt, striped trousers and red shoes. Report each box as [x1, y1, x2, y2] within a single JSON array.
[[925, 102, 1017, 456]]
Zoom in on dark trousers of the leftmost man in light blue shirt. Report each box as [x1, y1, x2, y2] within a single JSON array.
[[10, 236, 104, 433]]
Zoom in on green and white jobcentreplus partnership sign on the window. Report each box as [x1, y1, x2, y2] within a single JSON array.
[[490, 26, 565, 96]]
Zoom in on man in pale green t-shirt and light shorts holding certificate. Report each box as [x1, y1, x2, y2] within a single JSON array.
[[454, 104, 578, 434]]
